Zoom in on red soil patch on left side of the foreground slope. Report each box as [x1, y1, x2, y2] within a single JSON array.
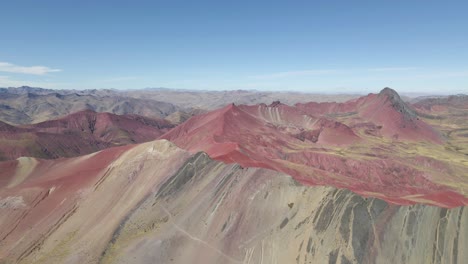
[[0, 145, 135, 250]]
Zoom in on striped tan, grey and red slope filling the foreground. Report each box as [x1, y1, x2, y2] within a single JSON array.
[[0, 141, 468, 264]]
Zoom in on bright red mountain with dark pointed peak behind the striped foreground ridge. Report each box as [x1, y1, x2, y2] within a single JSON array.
[[161, 89, 468, 207]]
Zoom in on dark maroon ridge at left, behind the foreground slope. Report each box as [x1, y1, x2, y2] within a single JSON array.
[[0, 110, 174, 160]]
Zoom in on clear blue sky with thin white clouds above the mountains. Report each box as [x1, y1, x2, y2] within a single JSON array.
[[0, 0, 468, 94]]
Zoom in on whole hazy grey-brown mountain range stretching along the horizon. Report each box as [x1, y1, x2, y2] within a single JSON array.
[[0, 86, 362, 124]]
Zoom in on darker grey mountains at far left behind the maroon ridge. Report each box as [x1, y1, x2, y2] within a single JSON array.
[[0, 87, 181, 124]]
